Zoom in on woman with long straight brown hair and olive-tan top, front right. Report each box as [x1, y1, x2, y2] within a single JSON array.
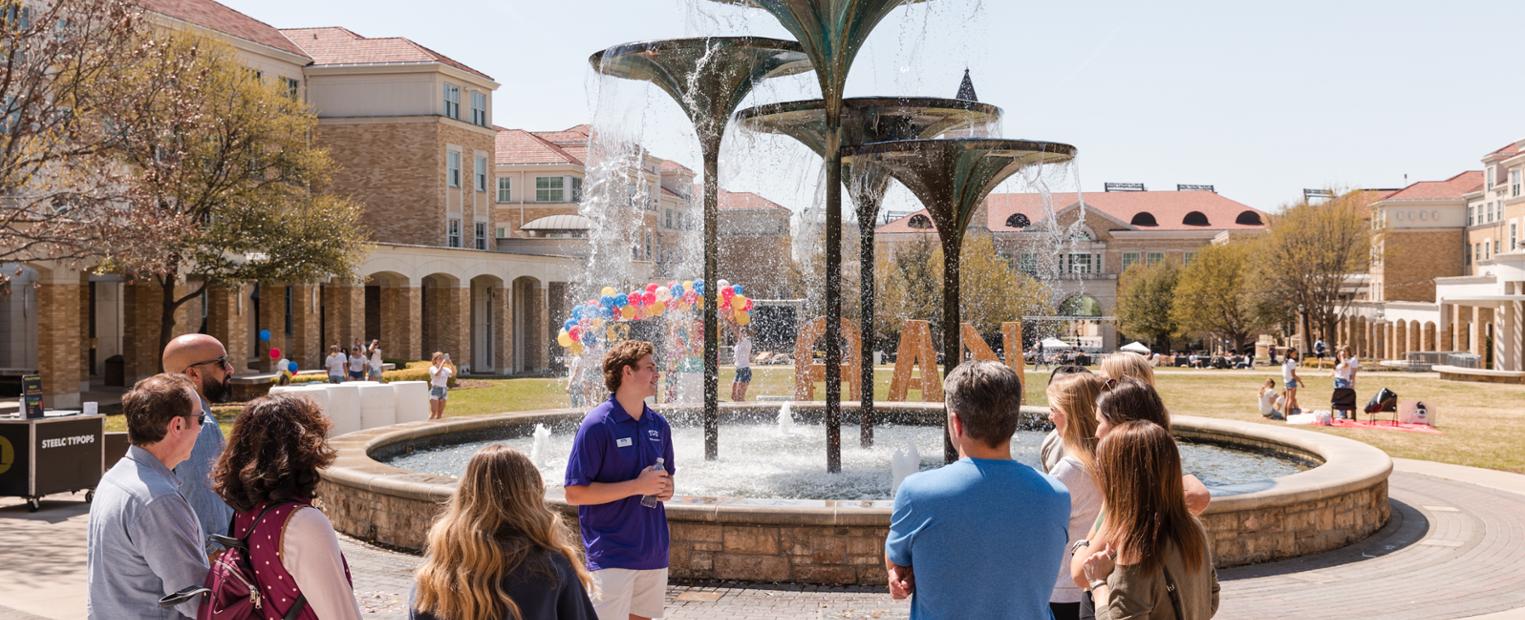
[[1077, 420, 1218, 620]]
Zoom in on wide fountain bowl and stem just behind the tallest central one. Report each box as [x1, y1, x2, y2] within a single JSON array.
[[737, 97, 1000, 448]]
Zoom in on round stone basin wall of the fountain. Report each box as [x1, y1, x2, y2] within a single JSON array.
[[319, 402, 1392, 585]]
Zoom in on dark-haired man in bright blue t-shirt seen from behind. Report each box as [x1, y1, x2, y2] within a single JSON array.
[[885, 361, 1069, 618]]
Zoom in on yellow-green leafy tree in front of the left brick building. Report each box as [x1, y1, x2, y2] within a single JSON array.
[[107, 34, 369, 350]]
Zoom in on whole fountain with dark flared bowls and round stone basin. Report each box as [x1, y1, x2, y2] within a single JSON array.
[[320, 0, 1391, 585]]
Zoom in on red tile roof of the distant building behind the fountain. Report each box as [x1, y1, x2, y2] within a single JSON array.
[[875, 192, 1266, 233]]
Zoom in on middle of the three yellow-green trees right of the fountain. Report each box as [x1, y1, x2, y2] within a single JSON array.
[[1171, 244, 1261, 350]]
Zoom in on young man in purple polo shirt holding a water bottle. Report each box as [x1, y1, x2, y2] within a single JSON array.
[[566, 340, 674, 620]]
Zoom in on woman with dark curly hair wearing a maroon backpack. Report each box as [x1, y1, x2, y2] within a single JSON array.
[[212, 395, 360, 620]]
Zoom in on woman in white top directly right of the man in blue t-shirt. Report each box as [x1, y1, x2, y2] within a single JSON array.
[[1048, 372, 1107, 620]]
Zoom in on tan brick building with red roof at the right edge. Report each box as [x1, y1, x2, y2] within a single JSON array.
[[1334, 140, 1525, 379]]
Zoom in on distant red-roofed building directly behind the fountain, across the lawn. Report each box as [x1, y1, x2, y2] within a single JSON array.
[[875, 189, 1266, 350]]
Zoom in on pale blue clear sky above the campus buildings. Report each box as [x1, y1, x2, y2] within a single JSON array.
[[223, 0, 1525, 210]]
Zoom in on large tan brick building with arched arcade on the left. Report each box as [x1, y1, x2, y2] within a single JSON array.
[[0, 0, 588, 407]]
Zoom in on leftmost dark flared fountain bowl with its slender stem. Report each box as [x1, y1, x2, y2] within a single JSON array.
[[589, 37, 810, 460]]
